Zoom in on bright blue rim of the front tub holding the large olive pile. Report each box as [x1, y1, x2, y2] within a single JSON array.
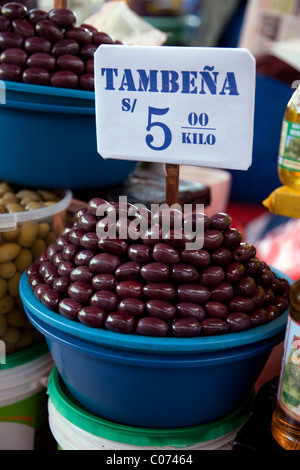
[[19, 268, 293, 354]]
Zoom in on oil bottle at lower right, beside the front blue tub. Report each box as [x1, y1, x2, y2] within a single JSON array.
[[271, 279, 300, 450]]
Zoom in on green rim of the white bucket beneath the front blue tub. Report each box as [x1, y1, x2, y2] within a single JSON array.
[[48, 367, 254, 447]]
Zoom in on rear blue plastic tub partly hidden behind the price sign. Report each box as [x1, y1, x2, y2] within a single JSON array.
[[0, 82, 136, 189]]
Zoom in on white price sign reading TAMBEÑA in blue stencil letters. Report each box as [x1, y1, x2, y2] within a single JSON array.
[[95, 45, 255, 170]]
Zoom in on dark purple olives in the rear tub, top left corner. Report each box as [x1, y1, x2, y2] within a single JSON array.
[[0, 2, 121, 91]]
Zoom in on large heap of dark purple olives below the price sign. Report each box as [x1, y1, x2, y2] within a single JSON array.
[[27, 198, 289, 337]]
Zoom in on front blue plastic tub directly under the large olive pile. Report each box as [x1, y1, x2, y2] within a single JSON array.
[[20, 270, 287, 428]]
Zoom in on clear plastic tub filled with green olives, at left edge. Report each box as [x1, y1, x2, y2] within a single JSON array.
[[0, 180, 72, 354]]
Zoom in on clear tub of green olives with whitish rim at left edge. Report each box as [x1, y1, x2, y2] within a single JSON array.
[[0, 188, 72, 354]]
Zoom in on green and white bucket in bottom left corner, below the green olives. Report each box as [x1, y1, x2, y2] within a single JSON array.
[[0, 342, 53, 450]]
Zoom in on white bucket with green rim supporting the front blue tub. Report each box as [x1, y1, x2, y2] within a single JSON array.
[[48, 367, 253, 451]]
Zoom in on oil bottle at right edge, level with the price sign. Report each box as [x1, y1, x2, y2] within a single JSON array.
[[278, 85, 300, 190]]
